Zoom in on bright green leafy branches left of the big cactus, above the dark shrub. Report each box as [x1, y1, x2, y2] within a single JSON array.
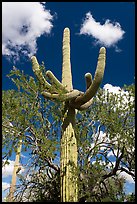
[[2, 68, 60, 167]]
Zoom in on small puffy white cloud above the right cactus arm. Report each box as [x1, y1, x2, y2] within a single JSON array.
[[80, 12, 125, 48]]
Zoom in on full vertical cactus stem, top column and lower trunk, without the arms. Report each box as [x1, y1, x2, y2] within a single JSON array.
[[60, 28, 78, 202]]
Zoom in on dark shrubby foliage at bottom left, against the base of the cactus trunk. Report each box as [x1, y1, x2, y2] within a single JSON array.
[[15, 168, 60, 202]]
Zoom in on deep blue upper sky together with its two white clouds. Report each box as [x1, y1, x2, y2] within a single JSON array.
[[2, 2, 135, 201]]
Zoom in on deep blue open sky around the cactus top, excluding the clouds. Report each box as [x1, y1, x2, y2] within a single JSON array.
[[2, 2, 135, 91]]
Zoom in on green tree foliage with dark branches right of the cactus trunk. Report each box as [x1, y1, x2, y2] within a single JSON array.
[[76, 84, 135, 202]]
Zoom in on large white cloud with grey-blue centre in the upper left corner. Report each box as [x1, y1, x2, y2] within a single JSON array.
[[2, 2, 53, 60]]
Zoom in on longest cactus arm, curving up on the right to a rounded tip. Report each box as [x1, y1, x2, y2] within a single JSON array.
[[75, 47, 106, 104]]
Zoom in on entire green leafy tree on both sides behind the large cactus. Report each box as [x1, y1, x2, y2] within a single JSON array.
[[2, 64, 135, 202]]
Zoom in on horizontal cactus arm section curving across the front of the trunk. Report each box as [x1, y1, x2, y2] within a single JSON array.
[[41, 89, 81, 101]]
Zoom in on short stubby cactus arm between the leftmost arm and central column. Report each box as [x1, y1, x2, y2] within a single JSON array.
[[46, 70, 68, 93]]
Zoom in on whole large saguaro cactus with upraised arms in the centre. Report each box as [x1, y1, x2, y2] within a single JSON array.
[[31, 28, 106, 202]]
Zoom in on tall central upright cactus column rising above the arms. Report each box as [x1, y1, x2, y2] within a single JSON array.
[[62, 28, 73, 91]]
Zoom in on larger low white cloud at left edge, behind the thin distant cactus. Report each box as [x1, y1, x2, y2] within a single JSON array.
[[2, 160, 25, 178]]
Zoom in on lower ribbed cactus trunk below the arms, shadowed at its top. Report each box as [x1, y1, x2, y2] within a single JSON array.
[[60, 108, 78, 202]]
